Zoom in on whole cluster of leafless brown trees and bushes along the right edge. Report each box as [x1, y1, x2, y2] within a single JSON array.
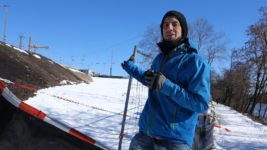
[[209, 7, 267, 123]]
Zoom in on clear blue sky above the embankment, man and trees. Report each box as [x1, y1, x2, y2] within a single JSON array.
[[0, 0, 267, 76]]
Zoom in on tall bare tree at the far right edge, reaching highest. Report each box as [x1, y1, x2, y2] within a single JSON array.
[[240, 7, 267, 116]]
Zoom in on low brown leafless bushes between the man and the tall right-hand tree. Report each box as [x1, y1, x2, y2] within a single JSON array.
[[211, 55, 250, 111]]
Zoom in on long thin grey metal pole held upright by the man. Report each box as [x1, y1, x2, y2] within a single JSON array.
[[118, 46, 137, 150]]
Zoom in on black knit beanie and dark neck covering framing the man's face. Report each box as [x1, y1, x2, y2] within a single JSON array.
[[158, 10, 188, 53]]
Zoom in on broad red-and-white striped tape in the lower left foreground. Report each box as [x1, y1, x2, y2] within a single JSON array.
[[0, 80, 108, 150]]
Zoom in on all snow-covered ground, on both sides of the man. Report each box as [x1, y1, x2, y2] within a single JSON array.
[[26, 78, 267, 150]]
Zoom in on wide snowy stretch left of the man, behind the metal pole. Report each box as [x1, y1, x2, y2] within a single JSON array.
[[26, 78, 147, 149]]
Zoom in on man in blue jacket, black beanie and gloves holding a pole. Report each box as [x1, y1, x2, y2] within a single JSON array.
[[122, 11, 211, 150]]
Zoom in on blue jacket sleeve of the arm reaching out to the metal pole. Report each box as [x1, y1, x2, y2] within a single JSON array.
[[123, 61, 145, 85]]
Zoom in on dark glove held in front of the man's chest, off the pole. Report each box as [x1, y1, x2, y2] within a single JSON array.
[[144, 70, 166, 90]]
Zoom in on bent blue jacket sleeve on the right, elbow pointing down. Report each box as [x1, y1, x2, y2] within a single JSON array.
[[160, 57, 210, 113]]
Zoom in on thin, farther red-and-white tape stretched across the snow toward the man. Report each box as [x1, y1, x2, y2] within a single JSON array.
[[0, 77, 139, 119]]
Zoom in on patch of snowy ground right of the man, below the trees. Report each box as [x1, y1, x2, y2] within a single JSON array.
[[215, 104, 267, 150]]
